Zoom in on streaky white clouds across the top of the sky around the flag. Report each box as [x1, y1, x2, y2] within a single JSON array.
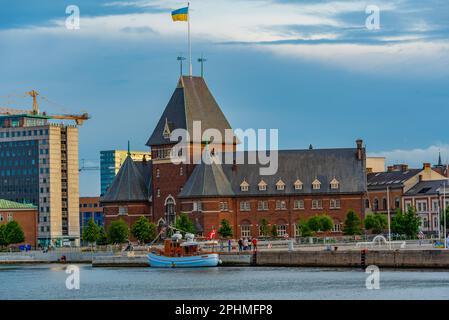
[[0, 0, 449, 75]]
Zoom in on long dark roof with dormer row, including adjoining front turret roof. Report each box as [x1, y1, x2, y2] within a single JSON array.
[[179, 149, 366, 198]]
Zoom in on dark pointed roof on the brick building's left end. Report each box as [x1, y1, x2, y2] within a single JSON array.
[[100, 156, 152, 203]]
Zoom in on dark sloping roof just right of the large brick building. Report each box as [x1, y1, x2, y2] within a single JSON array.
[[367, 169, 422, 190]]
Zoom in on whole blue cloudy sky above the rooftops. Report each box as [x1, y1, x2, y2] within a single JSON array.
[[0, 0, 449, 195]]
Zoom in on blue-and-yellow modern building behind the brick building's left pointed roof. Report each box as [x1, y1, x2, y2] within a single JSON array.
[[100, 150, 151, 195]]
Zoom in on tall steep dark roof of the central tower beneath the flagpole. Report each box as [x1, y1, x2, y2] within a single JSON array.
[[147, 76, 231, 146]]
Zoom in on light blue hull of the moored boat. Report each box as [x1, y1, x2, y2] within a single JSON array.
[[148, 253, 220, 268]]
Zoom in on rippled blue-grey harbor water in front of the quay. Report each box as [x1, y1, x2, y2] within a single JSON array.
[[0, 264, 449, 300]]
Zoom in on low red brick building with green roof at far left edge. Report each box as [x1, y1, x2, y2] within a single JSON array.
[[0, 199, 38, 248]]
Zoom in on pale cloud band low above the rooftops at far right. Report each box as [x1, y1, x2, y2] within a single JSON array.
[[368, 144, 449, 168]]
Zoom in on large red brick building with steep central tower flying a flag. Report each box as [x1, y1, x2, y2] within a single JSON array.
[[101, 77, 366, 237]]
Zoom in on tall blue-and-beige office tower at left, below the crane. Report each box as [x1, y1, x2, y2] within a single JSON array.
[[0, 107, 83, 246]]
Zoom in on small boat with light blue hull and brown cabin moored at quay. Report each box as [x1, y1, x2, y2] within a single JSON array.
[[148, 233, 220, 268]]
